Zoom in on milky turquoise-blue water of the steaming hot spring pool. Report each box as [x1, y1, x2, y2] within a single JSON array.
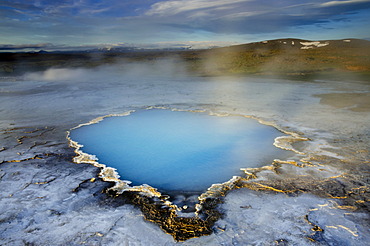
[[71, 109, 286, 191]]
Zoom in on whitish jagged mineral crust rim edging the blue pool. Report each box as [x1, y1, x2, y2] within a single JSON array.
[[66, 106, 310, 211]]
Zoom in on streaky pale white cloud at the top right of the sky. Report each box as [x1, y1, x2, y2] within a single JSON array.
[[146, 0, 370, 34]]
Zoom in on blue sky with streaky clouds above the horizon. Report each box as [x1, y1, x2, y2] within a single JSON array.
[[0, 0, 370, 50]]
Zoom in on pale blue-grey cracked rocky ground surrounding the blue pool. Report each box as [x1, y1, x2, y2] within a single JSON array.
[[0, 73, 370, 245]]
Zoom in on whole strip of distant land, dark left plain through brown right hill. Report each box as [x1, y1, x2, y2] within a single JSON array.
[[0, 38, 370, 81]]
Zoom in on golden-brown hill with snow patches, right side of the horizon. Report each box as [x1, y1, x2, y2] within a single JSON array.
[[184, 38, 370, 79]]
